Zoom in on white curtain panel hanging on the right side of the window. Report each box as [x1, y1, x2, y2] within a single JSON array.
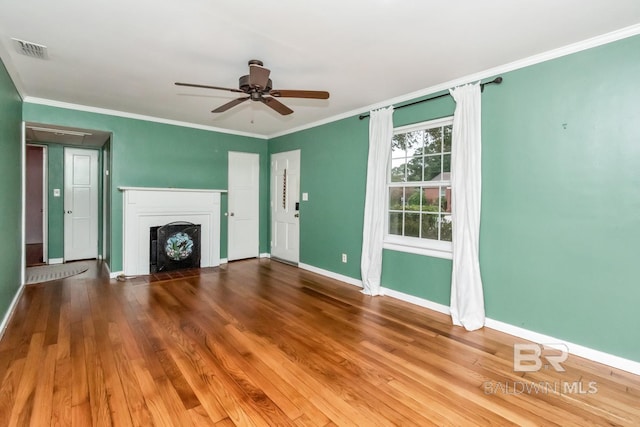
[[450, 83, 485, 331]]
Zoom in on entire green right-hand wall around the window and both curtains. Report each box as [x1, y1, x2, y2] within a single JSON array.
[[269, 36, 640, 361]]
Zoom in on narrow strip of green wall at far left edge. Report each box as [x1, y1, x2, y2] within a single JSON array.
[[0, 61, 23, 319]]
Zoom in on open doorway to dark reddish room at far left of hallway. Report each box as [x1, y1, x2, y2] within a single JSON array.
[[25, 144, 48, 267]]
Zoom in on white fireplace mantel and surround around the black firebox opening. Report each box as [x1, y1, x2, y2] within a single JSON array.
[[118, 187, 226, 275]]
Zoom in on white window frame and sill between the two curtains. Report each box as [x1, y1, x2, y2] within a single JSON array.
[[383, 116, 454, 259]]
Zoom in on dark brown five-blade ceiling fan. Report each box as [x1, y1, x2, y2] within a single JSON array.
[[176, 59, 329, 116]]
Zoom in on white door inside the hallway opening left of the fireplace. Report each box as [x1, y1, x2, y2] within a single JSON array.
[[64, 148, 98, 261]]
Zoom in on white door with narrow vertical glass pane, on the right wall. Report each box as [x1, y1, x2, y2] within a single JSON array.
[[271, 150, 300, 264]]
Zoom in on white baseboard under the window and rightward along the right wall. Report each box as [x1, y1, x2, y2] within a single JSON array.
[[380, 288, 640, 375]]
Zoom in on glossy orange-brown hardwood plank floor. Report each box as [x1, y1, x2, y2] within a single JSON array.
[[0, 260, 640, 426]]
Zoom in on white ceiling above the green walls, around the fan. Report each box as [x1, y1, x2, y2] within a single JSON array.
[[0, 0, 640, 136]]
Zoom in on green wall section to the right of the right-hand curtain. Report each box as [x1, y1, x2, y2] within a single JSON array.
[[480, 36, 640, 361]]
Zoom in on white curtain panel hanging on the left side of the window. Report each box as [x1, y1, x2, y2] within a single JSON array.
[[360, 106, 393, 295]]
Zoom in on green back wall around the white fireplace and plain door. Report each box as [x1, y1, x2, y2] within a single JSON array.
[[23, 103, 269, 272]]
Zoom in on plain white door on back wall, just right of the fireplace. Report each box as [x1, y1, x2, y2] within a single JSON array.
[[227, 151, 260, 261]]
